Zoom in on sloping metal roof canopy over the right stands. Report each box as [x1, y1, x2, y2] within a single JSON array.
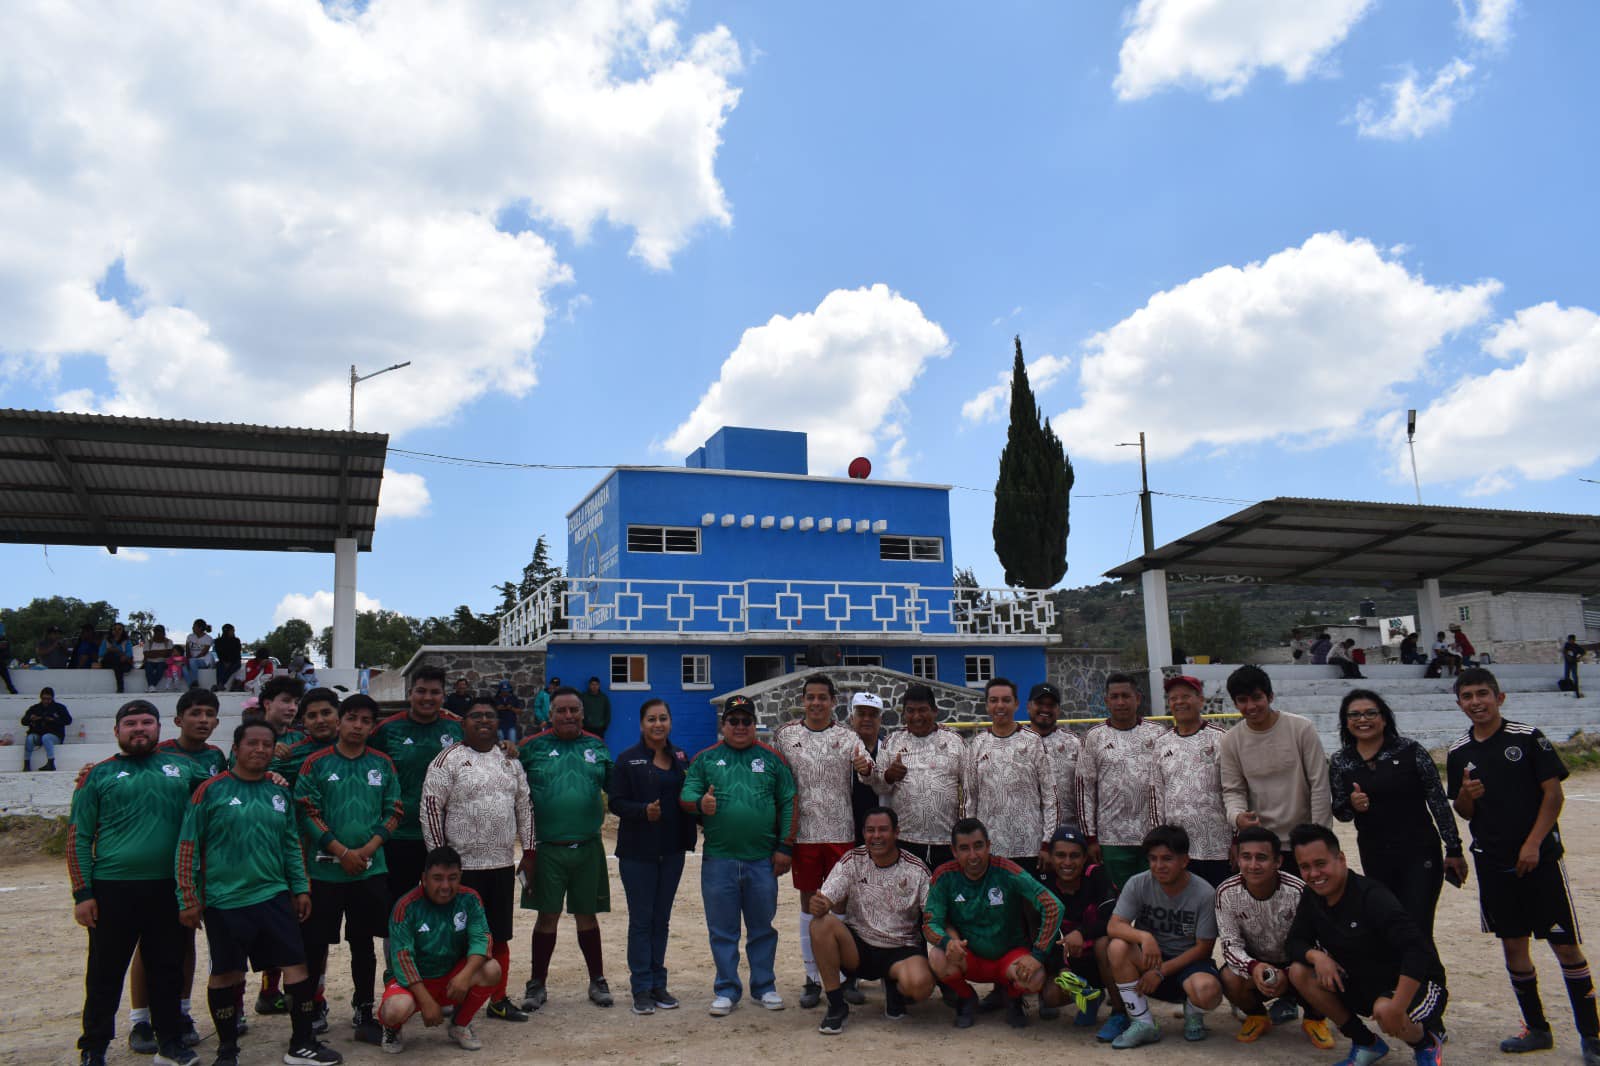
[[1106, 496, 1600, 592]]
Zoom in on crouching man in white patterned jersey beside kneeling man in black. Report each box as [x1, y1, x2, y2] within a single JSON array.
[[1216, 826, 1333, 1050]]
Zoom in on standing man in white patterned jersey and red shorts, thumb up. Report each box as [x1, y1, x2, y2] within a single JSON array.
[[773, 674, 872, 1008]]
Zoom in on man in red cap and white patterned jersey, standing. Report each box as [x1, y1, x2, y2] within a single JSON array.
[[1150, 675, 1234, 888]]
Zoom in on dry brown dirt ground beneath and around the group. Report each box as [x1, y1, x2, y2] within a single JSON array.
[[9, 771, 1600, 1066]]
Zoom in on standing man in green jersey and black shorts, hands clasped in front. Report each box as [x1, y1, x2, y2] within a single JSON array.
[[294, 693, 402, 1044]]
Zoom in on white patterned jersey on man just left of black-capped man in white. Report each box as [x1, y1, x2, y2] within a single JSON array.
[[965, 728, 1061, 858]]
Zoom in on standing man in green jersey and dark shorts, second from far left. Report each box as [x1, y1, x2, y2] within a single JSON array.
[[178, 720, 344, 1066]]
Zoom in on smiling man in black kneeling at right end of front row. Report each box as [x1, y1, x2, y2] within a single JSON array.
[[1288, 824, 1450, 1066]]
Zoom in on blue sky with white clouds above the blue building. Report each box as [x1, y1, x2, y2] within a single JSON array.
[[0, 0, 1600, 635]]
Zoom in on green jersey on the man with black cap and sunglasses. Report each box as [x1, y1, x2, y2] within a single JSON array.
[[682, 744, 795, 863]]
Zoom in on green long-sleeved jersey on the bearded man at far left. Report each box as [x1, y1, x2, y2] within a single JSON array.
[[67, 751, 202, 903]]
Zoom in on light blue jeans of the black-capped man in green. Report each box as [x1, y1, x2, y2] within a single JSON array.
[[701, 855, 778, 1002]]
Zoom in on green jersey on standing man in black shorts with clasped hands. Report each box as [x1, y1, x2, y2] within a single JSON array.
[[294, 746, 405, 880]]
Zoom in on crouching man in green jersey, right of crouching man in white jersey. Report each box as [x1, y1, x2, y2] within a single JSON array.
[[922, 818, 1061, 1029]]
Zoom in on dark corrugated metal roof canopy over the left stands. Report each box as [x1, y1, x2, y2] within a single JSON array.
[[0, 410, 389, 552]]
